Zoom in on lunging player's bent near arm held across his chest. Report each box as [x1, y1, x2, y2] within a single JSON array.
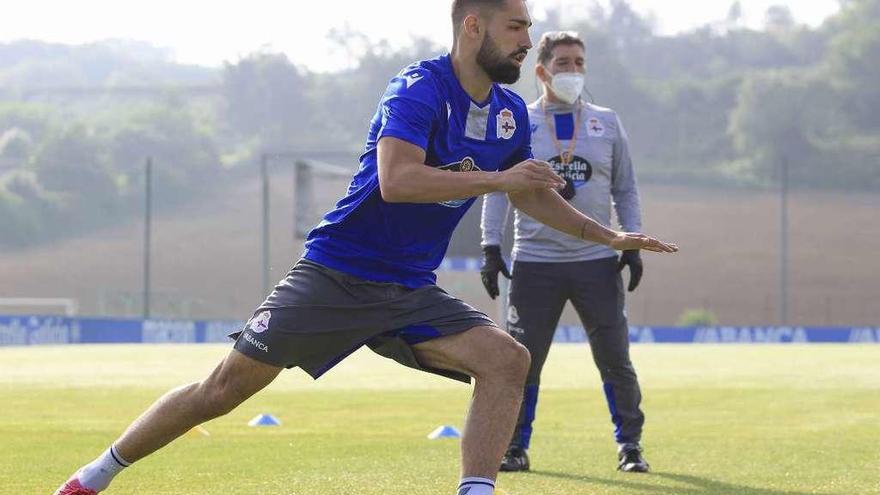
[[378, 137, 565, 203]]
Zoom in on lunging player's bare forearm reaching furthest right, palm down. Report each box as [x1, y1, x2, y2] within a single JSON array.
[[508, 190, 678, 253]]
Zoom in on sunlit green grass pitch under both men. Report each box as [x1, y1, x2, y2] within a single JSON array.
[[0, 345, 880, 495]]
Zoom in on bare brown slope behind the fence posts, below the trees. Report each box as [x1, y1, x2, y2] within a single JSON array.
[[0, 152, 880, 326]]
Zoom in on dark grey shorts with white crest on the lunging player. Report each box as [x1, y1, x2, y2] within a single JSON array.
[[230, 259, 496, 383]]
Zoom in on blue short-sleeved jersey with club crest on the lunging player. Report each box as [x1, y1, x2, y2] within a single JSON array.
[[304, 55, 532, 287]]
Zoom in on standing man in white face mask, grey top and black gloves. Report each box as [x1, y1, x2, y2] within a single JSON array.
[[481, 32, 649, 472]]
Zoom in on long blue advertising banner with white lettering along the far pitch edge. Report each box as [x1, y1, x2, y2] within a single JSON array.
[[0, 315, 880, 346]]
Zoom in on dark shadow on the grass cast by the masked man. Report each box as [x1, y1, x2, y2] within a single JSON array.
[[523, 471, 840, 495]]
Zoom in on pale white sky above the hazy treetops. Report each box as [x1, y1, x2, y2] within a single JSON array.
[[0, 0, 839, 71]]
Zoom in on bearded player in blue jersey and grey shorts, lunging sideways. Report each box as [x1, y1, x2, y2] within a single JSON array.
[[56, 0, 677, 495]]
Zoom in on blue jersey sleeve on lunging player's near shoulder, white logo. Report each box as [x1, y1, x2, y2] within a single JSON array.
[[377, 68, 440, 149]]
